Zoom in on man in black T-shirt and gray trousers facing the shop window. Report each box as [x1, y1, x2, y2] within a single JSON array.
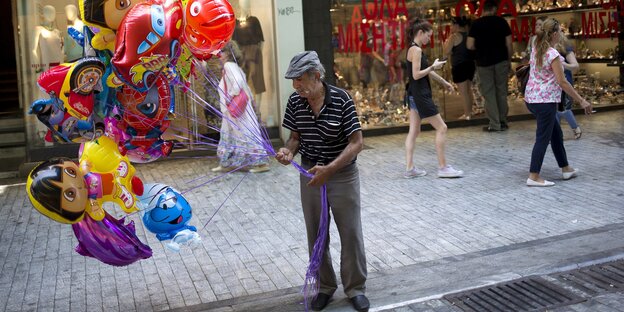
[[466, 0, 513, 132]]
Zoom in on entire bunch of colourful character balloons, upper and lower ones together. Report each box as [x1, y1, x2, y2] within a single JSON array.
[[26, 0, 236, 266]]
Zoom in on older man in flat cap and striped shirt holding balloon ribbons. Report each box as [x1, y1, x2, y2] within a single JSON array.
[[275, 51, 370, 311]]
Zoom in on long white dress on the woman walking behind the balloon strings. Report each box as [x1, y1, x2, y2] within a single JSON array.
[[217, 62, 269, 168]]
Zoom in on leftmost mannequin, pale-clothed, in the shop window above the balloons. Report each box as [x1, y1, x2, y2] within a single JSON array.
[[32, 5, 63, 72]]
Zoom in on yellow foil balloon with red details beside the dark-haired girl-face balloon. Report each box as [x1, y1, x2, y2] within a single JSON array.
[[80, 136, 143, 213]]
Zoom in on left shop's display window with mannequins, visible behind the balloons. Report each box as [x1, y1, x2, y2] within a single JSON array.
[[14, 0, 279, 156]]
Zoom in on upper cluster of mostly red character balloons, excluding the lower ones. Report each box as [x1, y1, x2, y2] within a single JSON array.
[[30, 0, 236, 162]]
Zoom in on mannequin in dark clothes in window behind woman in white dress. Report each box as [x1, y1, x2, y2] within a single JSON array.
[[232, 0, 266, 114]]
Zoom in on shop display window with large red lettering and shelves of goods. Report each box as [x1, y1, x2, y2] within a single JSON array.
[[330, 0, 624, 128]]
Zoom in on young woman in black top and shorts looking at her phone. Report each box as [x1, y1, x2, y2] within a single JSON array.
[[403, 19, 464, 179]]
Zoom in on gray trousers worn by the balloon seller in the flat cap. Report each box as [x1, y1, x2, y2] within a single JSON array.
[[300, 161, 367, 298]]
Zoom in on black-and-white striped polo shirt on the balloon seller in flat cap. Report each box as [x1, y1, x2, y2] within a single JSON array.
[[282, 82, 361, 165]]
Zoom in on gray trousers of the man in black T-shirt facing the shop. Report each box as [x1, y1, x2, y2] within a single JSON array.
[[477, 61, 509, 130]]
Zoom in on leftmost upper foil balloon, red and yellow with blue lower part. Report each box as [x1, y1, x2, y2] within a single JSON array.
[[29, 58, 104, 142]]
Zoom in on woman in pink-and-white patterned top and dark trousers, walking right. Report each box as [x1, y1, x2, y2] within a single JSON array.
[[524, 18, 592, 186]]
